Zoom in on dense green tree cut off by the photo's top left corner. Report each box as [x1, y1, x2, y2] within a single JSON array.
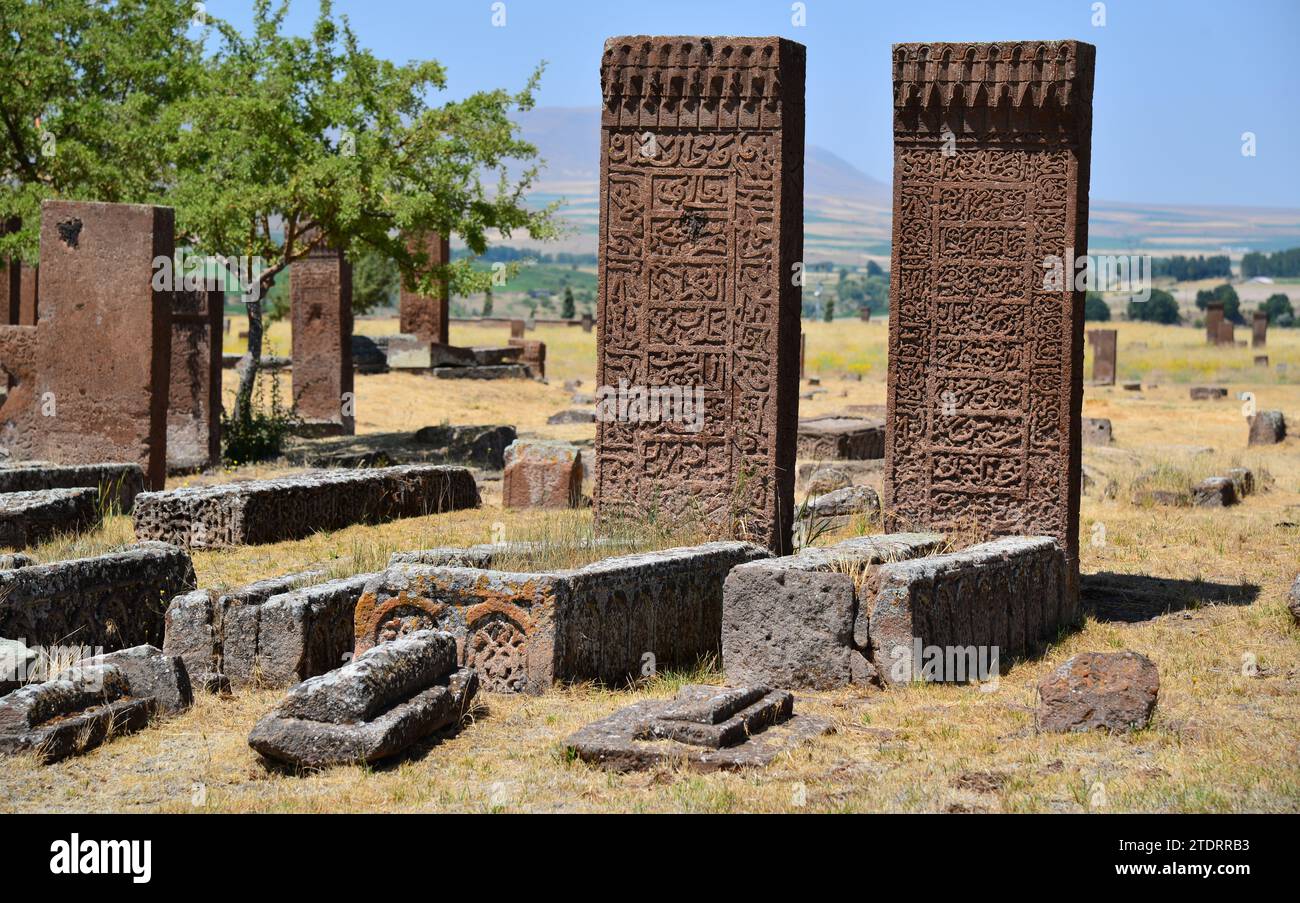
[[0, 0, 203, 262]]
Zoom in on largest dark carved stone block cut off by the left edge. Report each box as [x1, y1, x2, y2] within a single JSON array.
[[0, 542, 194, 650]]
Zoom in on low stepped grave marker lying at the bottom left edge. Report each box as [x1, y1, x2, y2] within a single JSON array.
[[0, 646, 192, 764]]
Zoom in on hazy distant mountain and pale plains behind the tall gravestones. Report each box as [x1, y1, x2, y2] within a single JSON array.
[[508, 107, 1300, 265]]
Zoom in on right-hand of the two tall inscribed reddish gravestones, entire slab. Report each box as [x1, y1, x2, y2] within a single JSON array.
[[884, 40, 1095, 592]]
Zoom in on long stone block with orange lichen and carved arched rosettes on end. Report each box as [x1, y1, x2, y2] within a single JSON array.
[[356, 542, 766, 693]]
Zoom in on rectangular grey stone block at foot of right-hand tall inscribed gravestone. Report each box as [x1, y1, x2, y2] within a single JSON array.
[[859, 537, 1079, 683]]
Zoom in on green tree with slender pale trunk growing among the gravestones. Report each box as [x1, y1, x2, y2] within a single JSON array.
[[169, 0, 556, 427]]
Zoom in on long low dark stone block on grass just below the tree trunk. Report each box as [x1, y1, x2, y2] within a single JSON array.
[[135, 464, 478, 548]]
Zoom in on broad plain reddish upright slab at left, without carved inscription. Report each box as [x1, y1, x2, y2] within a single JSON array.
[[0, 200, 174, 489]]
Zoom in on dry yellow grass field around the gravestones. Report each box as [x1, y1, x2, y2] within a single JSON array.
[[0, 320, 1300, 812]]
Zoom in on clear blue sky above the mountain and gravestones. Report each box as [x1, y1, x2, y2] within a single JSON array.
[[207, 0, 1300, 207]]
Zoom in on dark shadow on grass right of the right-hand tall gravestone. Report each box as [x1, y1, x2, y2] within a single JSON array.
[[1079, 572, 1260, 624]]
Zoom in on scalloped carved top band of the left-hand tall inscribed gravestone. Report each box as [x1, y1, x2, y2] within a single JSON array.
[[601, 35, 806, 127]]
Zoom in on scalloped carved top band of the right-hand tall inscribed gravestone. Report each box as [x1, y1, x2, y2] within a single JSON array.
[[893, 40, 1096, 109]]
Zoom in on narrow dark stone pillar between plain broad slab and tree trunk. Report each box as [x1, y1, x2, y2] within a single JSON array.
[[166, 290, 225, 472]]
